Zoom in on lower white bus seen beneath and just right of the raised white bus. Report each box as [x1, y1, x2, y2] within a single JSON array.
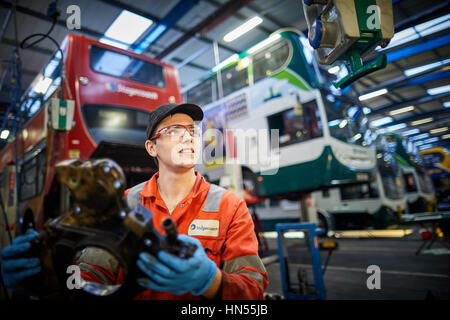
[[256, 151, 408, 235]]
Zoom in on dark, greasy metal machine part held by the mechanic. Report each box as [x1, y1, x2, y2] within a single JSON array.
[[26, 159, 196, 298]]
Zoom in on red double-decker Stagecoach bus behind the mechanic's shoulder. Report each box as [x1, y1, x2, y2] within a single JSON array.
[[0, 34, 182, 234]]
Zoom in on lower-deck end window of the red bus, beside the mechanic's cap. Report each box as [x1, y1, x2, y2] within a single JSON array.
[[81, 105, 149, 145]]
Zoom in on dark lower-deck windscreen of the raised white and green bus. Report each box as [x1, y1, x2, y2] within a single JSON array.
[[267, 100, 322, 147]]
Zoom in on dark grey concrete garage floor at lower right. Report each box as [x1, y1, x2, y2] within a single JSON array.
[[264, 230, 450, 300]]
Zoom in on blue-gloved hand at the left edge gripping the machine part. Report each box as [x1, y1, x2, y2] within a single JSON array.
[[1, 229, 41, 291]]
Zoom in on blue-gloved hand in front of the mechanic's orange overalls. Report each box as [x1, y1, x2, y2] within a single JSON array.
[[137, 235, 217, 296]]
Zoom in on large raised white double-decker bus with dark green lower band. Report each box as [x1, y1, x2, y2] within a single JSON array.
[[184, 29, 376, 200]]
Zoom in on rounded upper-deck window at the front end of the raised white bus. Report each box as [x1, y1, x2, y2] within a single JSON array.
[[252, 38, 292, 82]]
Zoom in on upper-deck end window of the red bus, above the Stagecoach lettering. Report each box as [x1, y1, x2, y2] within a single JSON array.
[[90, 46, 166, 88]]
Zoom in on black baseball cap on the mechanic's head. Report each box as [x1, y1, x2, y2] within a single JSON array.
[[147, 103, 203, 139]]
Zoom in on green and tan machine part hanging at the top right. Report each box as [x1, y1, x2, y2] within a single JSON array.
[[303, 0, 394, 89]]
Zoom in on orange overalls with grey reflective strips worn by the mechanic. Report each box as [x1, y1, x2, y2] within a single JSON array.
[[125, 171, 268, 300]]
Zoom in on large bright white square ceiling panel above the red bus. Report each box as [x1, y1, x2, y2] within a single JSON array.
[[105, 10, 153, 45]]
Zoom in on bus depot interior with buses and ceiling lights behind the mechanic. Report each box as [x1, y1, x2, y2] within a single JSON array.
[[0, 0, 450, 300]]
